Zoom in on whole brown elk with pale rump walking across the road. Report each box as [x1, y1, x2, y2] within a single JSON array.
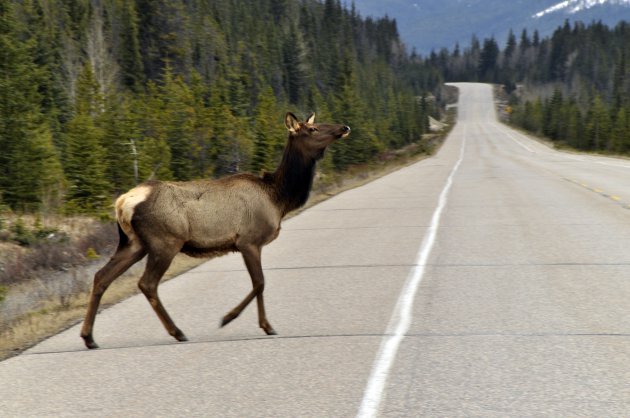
[[81, 112, 350, 349]]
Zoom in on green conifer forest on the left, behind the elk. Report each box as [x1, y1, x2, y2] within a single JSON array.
[[0, 0, 442, 214]]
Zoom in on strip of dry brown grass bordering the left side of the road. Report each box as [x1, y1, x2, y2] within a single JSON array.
[[0, 114, 454, 360]]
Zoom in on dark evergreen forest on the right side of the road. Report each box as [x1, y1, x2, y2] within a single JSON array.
[[429, 22, 630, 154]]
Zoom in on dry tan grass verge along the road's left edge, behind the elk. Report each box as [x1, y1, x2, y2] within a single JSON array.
[[0, 109, 456, 361]]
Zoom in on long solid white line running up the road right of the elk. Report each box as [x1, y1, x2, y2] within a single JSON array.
[[357, 125, 467, 418]]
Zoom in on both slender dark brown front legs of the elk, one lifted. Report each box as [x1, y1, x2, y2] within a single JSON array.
[[221, 245, 276, 335]]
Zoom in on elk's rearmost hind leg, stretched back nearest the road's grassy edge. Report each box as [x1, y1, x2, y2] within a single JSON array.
[[81, 242, 146, 348]]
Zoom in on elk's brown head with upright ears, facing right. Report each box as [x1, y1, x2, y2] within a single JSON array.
[[284, 112, 350, 160]]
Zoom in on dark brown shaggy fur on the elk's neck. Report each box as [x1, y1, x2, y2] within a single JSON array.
[[265, 142, 316, 216]]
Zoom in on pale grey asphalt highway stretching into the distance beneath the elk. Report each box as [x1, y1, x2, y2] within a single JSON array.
[[0, 84, 630, 417]]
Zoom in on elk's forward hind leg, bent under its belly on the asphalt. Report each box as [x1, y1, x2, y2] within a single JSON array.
[[138, 252, 188, 341]]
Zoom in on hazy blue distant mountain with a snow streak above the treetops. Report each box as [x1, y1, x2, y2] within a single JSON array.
[[354, 0, 630, 55]]
